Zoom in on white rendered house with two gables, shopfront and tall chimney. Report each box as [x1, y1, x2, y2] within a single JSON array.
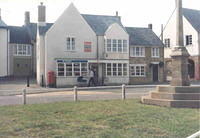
[[37, 4, 129, 87]]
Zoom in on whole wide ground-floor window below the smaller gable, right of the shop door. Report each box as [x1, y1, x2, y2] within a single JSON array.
[[106, 63, 128, 76]]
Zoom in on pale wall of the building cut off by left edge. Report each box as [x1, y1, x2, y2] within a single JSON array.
[[0, 28, 8, 77]]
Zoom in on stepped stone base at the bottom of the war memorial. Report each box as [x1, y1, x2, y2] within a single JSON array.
[[141, 86, 200, 108]]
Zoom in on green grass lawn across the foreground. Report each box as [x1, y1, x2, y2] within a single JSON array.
[[0, 100, 200, 138]]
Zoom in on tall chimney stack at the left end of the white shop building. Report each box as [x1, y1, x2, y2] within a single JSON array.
[[38, 2, 46, 26]]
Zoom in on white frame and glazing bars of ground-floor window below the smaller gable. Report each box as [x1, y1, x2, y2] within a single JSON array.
[[106, 63, 128, 77]]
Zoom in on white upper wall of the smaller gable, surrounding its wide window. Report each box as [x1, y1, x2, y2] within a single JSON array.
[[105, 23, 129, 59]]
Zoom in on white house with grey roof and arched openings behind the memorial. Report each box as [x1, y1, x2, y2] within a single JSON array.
[[163, 8, 200, 80]]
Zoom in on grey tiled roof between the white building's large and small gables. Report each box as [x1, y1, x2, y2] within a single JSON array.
[[82, 14, 123, 35]]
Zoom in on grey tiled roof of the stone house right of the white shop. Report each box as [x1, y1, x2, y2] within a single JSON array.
[[126, 27, 163, 46]]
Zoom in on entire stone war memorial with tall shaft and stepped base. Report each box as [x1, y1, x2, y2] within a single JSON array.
[[141, 0, 200, 108]]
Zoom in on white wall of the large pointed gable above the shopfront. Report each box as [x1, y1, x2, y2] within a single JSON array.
[[45, 4, 97, 85]]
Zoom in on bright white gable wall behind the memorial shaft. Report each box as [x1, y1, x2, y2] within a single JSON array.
[[163, 11, 199, 58]]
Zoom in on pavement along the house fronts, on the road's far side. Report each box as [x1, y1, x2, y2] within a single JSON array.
[[0, 78, 159, 96]]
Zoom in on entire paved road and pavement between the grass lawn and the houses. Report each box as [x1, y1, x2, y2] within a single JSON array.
[[0, 79, 200, 106]]
